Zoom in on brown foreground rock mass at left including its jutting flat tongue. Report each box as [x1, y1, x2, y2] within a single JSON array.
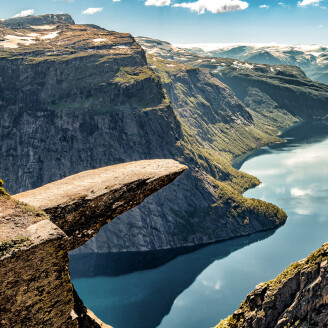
[[0, 160, 186, 328]]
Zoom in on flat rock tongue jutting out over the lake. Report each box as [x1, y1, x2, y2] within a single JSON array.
[[14, 159, 187, 249]]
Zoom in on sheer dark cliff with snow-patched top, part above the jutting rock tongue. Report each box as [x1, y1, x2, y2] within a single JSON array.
[[0, 15, 179, 193]]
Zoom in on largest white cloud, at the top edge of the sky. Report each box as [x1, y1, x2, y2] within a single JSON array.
[[173, 0, 248, 14]]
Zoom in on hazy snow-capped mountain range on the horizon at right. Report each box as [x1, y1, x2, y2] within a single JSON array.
[[178, 45, 328, 84]]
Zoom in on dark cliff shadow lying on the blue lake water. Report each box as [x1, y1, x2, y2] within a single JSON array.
[[70, 230, 275, 328]]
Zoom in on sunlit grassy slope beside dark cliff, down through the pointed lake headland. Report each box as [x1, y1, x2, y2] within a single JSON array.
[[148, 56, 286, 228]]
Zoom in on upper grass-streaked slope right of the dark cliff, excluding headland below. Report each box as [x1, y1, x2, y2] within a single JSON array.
[[147, 55, 281, 163]]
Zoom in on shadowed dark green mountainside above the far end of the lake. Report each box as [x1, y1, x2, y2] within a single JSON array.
[[219, 65, 328, 120]]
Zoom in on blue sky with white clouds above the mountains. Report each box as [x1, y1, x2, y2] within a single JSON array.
[[0, 0, 328, 45]]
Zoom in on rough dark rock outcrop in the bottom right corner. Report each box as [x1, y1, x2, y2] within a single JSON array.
[[216, 243, 328, 328]]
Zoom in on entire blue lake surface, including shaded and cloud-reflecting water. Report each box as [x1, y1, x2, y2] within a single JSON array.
[[70, 122, 328, 328]]
